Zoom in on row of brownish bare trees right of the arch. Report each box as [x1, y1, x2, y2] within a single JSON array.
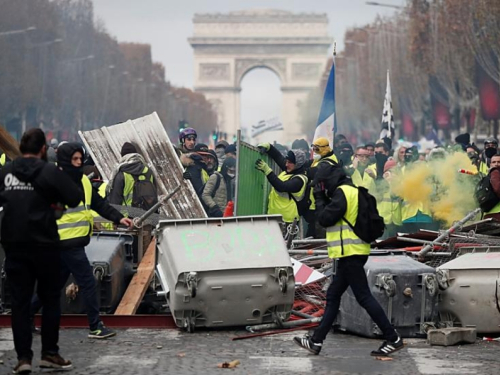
[[301, 0, 500, 142]]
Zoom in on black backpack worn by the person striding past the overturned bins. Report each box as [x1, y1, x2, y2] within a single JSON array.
[[343, 186, 385, 243]]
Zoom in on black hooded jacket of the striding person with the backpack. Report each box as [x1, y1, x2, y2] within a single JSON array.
[[314, 163, 354, 228]]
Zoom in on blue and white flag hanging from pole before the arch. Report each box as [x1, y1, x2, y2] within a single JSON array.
[[314, 59, 337, 147]]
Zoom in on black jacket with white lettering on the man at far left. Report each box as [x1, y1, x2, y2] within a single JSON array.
[[0, 157, 83, 251]]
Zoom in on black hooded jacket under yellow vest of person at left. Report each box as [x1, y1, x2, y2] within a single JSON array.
[[57, 143, 123, 249]]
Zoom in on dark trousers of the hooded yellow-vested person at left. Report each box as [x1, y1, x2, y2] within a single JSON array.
[[31, 247, 100, 331]]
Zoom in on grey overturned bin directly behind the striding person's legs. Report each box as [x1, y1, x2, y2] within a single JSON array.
[[333, 250, 439, 337]]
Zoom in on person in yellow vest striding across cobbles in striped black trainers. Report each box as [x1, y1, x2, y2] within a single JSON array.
[[294, 163, 403, 356]]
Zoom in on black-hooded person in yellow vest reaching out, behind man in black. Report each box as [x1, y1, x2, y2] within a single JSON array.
[[32, 143, 133, 339]]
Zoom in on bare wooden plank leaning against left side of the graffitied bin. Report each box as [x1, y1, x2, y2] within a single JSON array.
[[115, 239, 156, 315]]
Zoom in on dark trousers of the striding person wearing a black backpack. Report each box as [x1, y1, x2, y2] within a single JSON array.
[[312, 255, 398, 342]]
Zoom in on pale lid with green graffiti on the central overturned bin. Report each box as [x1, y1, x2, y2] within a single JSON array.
[[157, 215, 292, 273]]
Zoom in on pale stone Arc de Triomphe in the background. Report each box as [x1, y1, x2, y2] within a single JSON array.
[[189, 10, 332, 142]]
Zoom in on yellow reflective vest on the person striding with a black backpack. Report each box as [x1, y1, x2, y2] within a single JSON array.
[[326, 185, 370, 258]]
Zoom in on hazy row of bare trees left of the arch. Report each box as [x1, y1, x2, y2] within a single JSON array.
[[0, 0, 217, 140]]
